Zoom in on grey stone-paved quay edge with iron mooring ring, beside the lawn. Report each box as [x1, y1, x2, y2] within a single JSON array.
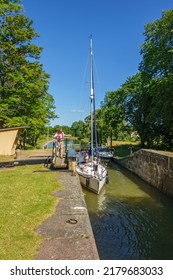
[[36, 170, 99, 260]]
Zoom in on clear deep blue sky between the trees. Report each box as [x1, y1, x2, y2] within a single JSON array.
[[22, 0, 173, 126]]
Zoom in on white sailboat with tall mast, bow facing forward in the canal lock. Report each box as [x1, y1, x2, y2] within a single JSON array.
[[76, 36, 108, 194]]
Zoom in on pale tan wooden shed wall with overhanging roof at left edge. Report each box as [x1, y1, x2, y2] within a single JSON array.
[[0, 126, 26, 156]]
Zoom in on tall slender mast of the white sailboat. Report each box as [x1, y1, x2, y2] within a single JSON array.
[[90, 35, 94, 160]]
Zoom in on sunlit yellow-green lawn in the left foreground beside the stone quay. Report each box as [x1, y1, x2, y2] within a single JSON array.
[[0, 165, 61, 260]]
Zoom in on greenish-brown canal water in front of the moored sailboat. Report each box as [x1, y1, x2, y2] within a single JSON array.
[[84, 163, 173, 260]]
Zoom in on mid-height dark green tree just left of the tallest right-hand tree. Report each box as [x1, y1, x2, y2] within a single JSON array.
[[122, 73, 154, 146]]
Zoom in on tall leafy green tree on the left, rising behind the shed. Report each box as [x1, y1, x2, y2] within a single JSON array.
[[0, 0, 56, 145]]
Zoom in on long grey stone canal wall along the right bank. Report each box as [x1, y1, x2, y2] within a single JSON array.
[[115, 149, 173, 197]]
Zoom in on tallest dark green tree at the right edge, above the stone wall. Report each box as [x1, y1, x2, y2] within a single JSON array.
[[139, 10, 173, 147]]
